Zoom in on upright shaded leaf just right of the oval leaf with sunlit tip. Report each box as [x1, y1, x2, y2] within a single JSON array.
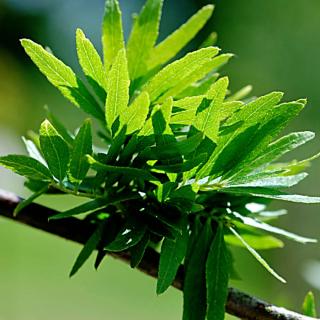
[[68, 120, 92, 184]]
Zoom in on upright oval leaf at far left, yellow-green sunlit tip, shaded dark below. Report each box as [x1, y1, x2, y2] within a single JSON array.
[[40, 120, 69, 181]]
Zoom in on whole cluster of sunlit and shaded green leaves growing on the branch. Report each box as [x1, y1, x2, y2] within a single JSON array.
[[0, 0, 320, 320]]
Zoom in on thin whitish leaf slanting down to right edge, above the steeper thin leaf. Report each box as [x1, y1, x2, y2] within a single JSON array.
[[232, 212, 317, 244]]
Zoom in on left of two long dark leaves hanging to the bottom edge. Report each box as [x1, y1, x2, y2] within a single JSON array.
[[183, 220, 212, 320]]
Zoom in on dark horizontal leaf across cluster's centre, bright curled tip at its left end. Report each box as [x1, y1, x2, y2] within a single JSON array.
[[87, 156, 158, 181]]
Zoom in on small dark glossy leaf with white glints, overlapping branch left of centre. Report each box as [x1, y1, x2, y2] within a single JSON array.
[[105, 221, 146, 252]]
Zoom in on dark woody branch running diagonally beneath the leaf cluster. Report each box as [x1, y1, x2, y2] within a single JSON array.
[[0, 190, 313, 320]]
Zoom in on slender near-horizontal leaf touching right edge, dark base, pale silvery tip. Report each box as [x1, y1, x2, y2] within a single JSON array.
[[223, 187, 320, 203]]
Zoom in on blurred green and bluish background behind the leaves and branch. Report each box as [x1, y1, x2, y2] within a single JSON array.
[[0, 0, 320, 320]]
